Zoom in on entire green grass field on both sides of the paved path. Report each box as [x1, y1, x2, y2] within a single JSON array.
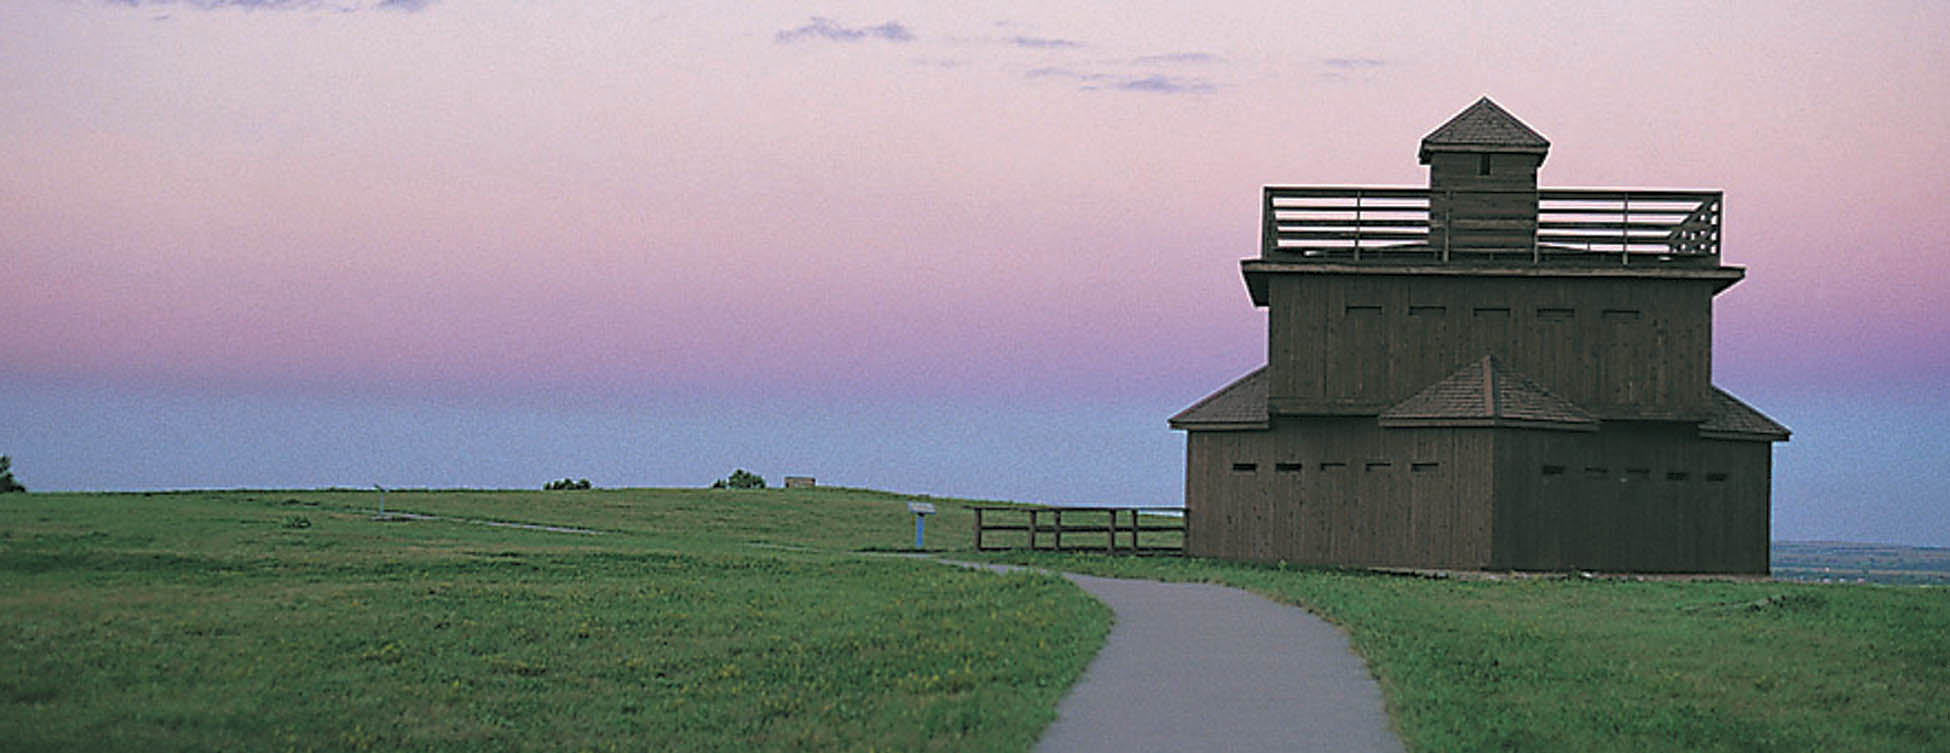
[[0, 490, 1950, 751]]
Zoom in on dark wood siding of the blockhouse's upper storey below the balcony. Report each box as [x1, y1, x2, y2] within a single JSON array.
[[1268, 275, 1714, 419]]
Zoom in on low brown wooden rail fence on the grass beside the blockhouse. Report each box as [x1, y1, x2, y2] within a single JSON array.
[[969, 505, 1186, 554]]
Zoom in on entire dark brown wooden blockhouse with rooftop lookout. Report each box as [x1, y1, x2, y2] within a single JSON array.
[[1170, 98, 1788, 574]]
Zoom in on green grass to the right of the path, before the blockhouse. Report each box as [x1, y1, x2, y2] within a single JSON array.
[[991, 554, 1950, 753]]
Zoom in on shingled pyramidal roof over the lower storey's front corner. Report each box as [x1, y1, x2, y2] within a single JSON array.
[[1379, 355, 1597, 431]]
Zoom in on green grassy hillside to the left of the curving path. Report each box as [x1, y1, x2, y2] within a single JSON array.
[[0, 490, 1110, 751]]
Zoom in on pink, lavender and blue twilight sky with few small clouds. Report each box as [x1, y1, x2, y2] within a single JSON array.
[[0, 0, 1950, 546]]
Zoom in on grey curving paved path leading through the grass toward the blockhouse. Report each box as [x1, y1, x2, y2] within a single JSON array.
[[1035, 574, 1402, 753]]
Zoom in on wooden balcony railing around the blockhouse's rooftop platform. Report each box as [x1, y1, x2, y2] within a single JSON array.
[[1260, 185, 1722, 263]]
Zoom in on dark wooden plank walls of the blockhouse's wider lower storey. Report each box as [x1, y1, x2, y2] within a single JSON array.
[[1186, 416, 1773, 574]]
